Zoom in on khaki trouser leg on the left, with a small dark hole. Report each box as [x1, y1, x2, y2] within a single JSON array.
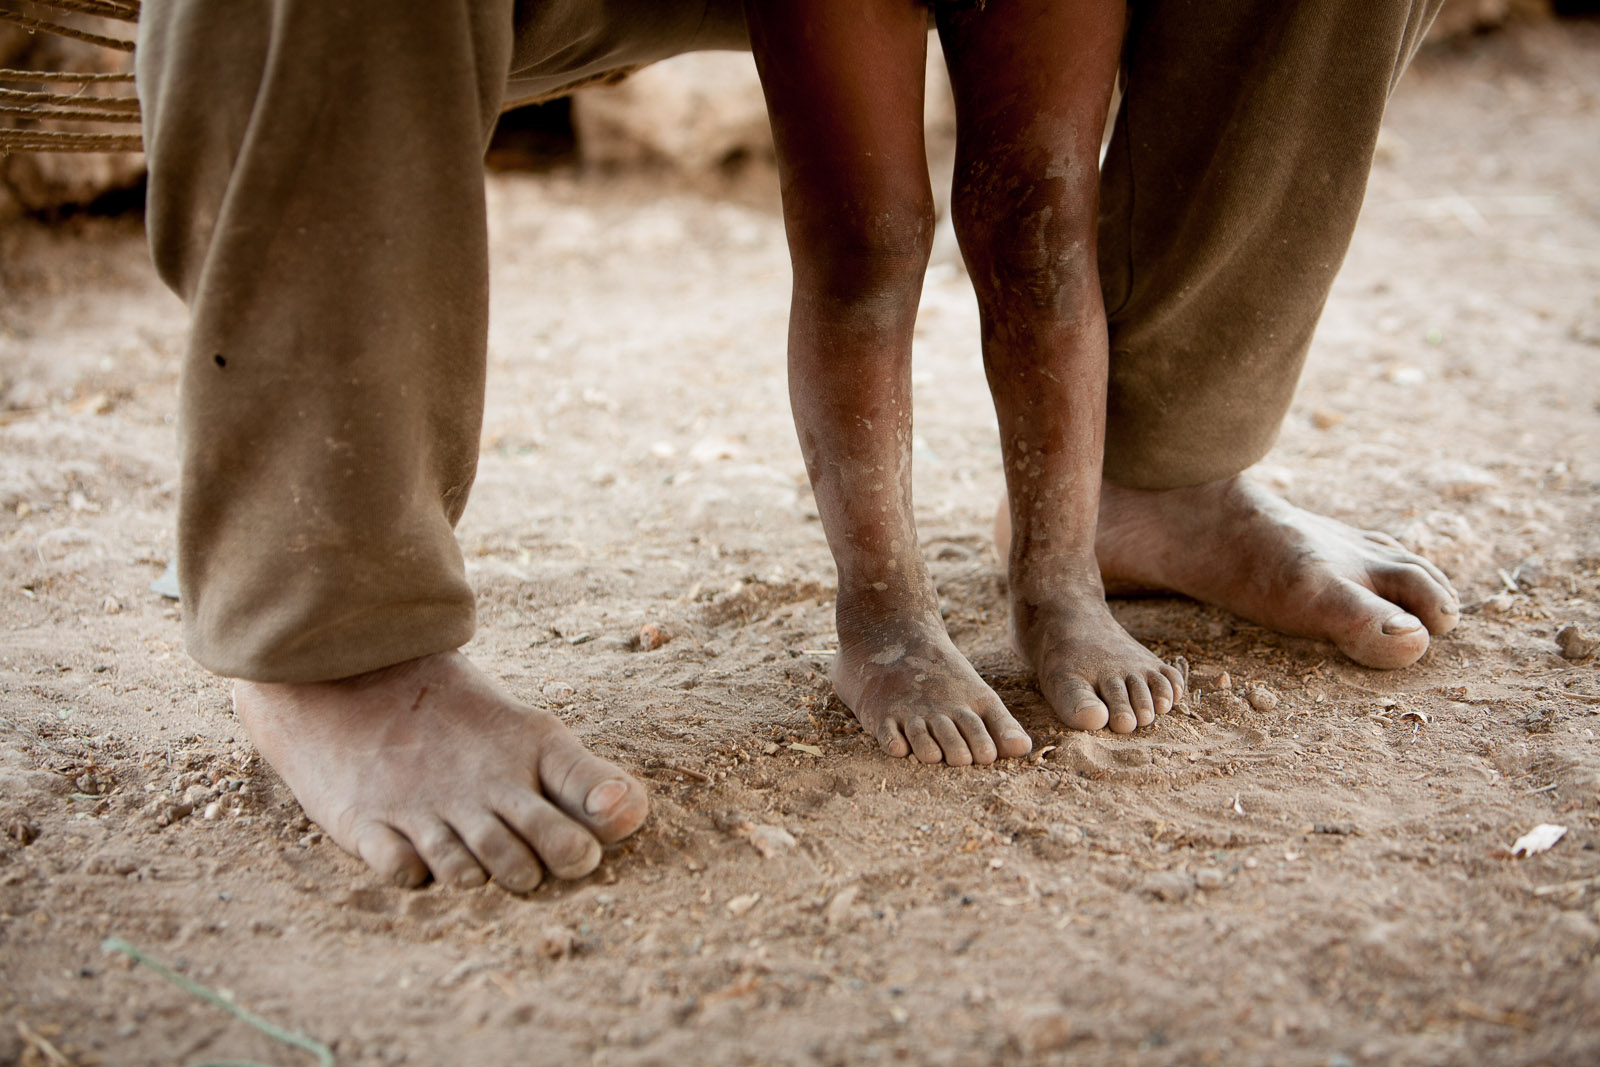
[[138, 0, 512, 681]]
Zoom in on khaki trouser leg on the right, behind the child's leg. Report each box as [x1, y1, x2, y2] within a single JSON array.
[[1099, 0, 1442, 490]]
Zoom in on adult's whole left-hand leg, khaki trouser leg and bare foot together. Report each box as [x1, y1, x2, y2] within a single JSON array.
[[138, 0, 645, 888]]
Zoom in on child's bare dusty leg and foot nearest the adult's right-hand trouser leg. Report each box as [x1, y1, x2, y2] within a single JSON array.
[[939, 0, 1182, 733]]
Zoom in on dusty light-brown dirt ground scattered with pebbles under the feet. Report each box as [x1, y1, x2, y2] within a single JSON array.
[[0, 22, 1600, 1067]]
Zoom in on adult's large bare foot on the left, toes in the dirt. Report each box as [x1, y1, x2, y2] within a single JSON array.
[[234, 653, 648, 893]]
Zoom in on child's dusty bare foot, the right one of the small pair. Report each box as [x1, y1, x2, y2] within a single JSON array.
[[1011, 585, 1184, 734]]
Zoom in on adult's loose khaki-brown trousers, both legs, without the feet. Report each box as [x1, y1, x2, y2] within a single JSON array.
[[138, 0, 1438, 681]]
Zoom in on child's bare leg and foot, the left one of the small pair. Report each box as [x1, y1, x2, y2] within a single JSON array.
[[747, 0, 1029, 763]]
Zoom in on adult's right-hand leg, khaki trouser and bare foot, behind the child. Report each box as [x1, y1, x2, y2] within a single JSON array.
[[1049, 0, 1459, 667]]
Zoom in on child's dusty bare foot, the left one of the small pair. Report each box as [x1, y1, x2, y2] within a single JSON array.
[[834, 611, 1034, 766]]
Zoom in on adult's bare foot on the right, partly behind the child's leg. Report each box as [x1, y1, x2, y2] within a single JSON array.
[[1094, 475, 1461, 669]]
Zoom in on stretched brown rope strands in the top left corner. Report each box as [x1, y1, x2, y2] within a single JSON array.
[[0, 0, 141, 155]]
